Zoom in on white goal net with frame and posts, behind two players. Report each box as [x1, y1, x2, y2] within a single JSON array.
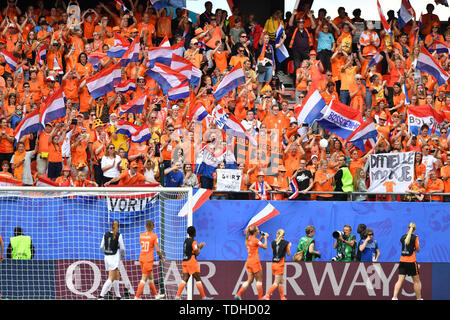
[[0, 187, 192, 300]]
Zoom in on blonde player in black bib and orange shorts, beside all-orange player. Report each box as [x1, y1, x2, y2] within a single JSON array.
[[264, 229, 291, 300]]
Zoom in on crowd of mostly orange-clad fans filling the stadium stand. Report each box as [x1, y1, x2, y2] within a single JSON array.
[[0, 0, 450, 201]]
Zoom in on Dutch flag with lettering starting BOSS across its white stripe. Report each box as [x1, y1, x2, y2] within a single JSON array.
[[317, 100, 363, 139]]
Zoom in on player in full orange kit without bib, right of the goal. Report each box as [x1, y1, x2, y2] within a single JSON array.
[[234, 225, 269, 300]]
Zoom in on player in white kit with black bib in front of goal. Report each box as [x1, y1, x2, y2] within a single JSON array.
[[99, 221, 125, 300]]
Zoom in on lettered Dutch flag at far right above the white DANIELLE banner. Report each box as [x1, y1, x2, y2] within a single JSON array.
[[407, 104, 445, 135]]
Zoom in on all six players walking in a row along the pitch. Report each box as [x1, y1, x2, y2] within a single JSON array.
[[99, 220, 422, 300]]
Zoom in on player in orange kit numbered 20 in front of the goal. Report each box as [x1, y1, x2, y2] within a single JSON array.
[[134, 220, 164, 300]]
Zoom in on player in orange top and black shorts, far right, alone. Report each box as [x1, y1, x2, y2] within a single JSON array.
[[392, 222, 422, 300]]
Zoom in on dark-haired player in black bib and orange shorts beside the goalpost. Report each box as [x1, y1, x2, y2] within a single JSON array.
[[175, 226, 212, 300]]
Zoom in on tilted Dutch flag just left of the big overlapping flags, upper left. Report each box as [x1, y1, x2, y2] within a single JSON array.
[[86, 61, 122, 99]]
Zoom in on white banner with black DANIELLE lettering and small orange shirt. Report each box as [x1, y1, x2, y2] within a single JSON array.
[[369, 152, 414, 193]]
